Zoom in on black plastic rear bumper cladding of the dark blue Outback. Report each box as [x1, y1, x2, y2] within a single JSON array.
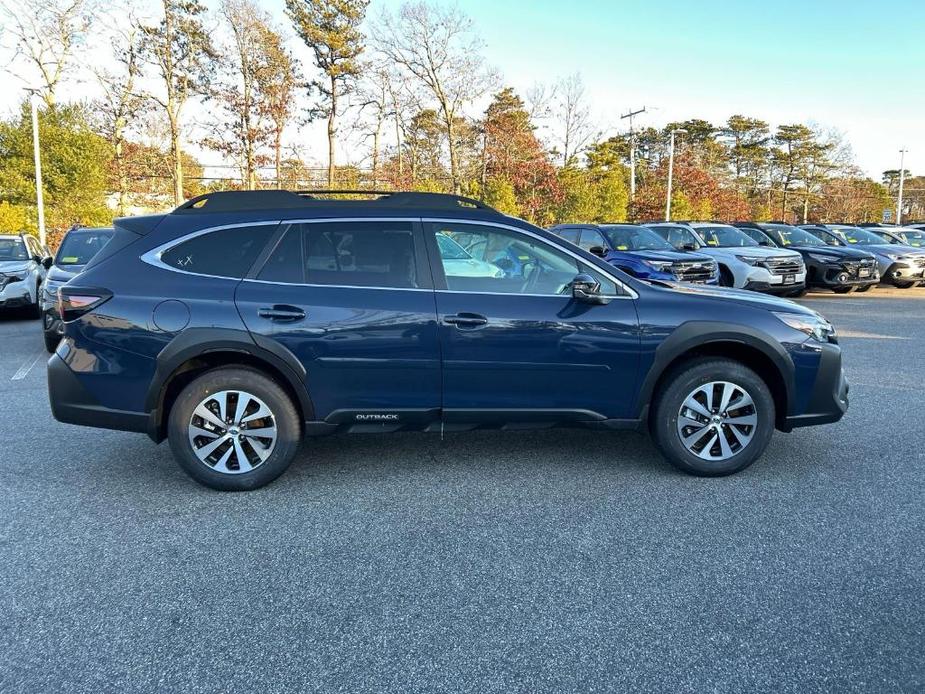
[[48, 354, 150, 433]]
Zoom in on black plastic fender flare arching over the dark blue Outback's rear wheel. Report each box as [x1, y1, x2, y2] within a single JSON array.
[[145, 328, 314, 421]]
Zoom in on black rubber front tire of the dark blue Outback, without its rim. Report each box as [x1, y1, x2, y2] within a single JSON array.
[[649, 357, 776, 477]]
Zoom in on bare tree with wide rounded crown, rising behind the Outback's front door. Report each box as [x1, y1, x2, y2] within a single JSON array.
[[375, 2, 495, 193]]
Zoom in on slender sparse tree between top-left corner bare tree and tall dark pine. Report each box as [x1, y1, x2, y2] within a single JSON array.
[[94, 18, 145, 215]]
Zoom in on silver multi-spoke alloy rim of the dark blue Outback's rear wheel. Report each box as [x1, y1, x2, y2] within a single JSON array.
[[188, 390, 278, 475]]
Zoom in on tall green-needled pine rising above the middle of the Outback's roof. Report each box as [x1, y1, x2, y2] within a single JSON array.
[[286, 0, 369, 186]]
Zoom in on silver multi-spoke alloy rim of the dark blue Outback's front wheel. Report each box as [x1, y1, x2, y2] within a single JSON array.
[[678, 381, 758, 462]]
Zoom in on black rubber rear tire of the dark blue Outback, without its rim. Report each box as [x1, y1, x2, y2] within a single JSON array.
[[167, 366, 302, 491]]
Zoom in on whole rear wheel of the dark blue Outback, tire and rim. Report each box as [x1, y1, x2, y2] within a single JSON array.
[[167, 367, 301, 491]]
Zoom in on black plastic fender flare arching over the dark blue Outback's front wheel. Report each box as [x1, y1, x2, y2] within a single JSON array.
[[636, 321, 796, 417]]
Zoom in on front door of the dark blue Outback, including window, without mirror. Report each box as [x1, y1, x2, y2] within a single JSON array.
[[424, 220, 639, 421]]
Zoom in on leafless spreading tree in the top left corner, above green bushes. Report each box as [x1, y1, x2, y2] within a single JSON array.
[[0, 0, 96, 108]]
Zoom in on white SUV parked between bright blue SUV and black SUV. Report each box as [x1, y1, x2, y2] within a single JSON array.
[[647, 222, 806, 296]]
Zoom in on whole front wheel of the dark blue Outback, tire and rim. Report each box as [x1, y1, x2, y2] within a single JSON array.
[[651, 358, 775, 477]]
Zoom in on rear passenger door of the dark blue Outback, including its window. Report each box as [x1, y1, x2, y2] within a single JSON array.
[[236, 219, 440, 428]]
